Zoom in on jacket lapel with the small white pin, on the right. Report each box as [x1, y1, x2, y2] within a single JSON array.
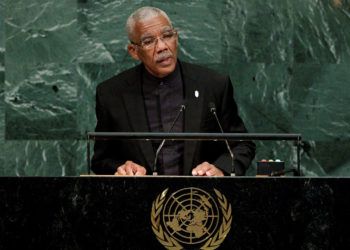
[[181, 63, 205, 175]]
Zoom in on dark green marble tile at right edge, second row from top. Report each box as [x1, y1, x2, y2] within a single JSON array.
[[290, 63, 350, 141]]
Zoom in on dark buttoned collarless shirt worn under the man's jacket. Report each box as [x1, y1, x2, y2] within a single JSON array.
[[142, 63, 184, 175]]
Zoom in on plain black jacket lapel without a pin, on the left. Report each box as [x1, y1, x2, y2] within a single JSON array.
[[123, 65, 155, 170]]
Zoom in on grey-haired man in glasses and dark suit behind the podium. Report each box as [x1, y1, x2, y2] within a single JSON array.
[[92, 7, 255, 176]]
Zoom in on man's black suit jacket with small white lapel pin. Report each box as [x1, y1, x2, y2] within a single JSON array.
[[91, 62, 255, 175]]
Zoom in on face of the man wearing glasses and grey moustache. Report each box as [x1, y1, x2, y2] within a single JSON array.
[[128, 15, 178, 78]]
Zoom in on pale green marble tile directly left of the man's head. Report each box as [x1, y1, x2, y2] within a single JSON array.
[[77, 0, 137, 65]]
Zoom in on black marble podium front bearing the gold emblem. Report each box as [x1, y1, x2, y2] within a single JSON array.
[[0, 177, 350, 250]]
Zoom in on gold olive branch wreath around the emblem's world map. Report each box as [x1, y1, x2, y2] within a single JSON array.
[[151, 188, 232, 250]]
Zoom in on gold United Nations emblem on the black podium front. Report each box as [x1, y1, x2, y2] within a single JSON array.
[[151, 187, 232, 250]]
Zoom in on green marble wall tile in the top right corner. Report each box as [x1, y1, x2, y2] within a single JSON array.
[[291, 0, 350, 63]]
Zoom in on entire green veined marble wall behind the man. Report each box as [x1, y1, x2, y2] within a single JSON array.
[[0, 0, 350, 176]]
